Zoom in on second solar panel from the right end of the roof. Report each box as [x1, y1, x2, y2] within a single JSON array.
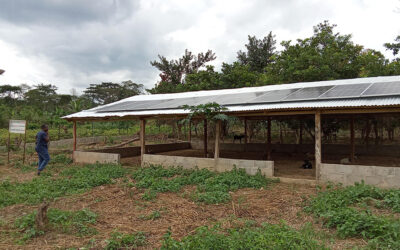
[[318, 83, 371, 99]]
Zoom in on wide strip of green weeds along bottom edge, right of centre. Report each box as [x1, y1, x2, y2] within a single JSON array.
[[161, 224, 328, 250]]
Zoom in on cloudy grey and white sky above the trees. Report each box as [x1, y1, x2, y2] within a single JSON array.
[[0, 0, 400, 93]]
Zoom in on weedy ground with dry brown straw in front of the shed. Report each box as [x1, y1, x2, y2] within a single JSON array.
[[0, 149, 400, 249]]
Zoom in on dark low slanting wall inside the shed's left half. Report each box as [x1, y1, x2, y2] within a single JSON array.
[[91, 142, 190, 158]]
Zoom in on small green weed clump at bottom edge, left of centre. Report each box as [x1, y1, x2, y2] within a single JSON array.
[[105, 232, 147, 250]]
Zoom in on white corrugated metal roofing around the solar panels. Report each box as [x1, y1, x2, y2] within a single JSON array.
[[63, 76, 400, 120]]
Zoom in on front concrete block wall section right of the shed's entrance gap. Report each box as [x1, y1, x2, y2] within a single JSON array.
[[321, 163, 400, 188]]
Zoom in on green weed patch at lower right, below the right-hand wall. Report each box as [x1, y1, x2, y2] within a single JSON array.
[[305, 183, 400, 249]]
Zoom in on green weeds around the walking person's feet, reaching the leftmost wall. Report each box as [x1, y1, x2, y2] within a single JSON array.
[[0, 164, 126, 207]]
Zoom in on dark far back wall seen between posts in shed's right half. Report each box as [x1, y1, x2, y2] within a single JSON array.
[[191, 141, 400, 157]]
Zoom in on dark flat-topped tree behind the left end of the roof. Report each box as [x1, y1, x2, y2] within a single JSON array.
[[84, 80, 143, 105]]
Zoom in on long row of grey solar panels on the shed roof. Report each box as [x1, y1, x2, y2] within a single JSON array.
[[96, 82, 400, 112]]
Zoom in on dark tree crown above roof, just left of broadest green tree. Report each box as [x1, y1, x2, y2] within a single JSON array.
[[237, 32, 276, 73]]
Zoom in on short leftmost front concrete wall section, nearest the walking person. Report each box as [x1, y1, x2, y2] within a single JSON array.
[[72, 151, 121, 164]]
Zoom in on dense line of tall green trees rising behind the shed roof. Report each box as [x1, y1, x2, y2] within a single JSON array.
[[148, 21, 400, 93]]
